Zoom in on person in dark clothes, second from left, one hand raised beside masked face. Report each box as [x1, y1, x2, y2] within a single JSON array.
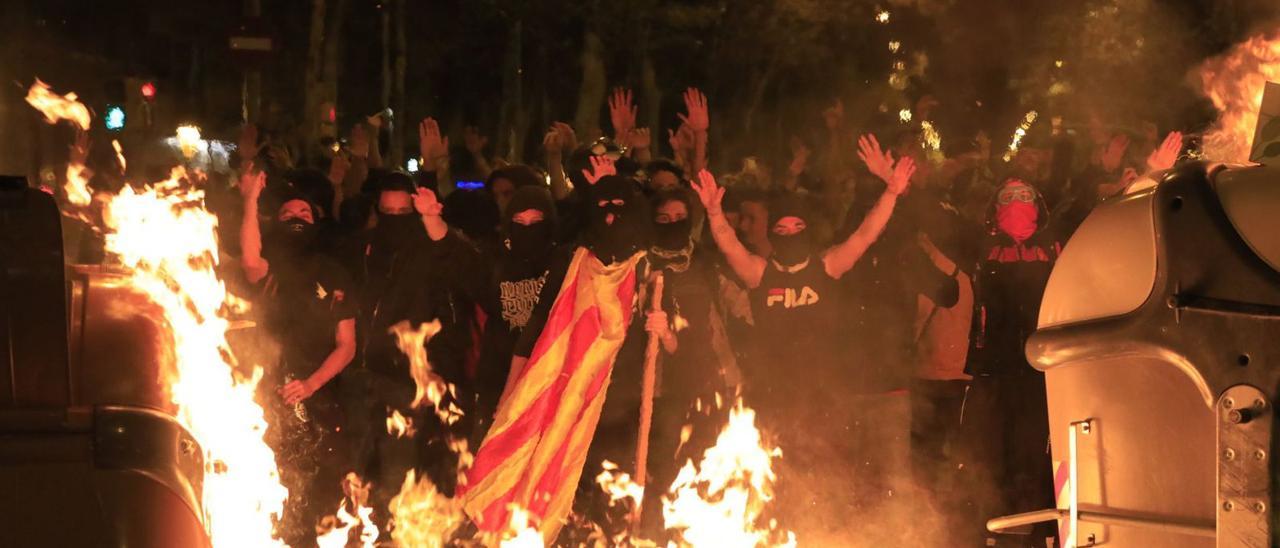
[[344, 172, 483, 520]]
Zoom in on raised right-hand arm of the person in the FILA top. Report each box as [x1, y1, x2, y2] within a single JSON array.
[[822, 136, 915, 279]]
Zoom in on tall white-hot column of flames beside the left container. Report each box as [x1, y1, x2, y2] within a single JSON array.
[[102, 169, 287, 547]]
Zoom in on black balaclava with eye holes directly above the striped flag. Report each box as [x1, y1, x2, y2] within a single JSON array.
[[585, 175, 652, 264]]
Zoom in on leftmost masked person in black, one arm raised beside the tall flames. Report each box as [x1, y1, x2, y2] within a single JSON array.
[[241, 172, 356, 545]]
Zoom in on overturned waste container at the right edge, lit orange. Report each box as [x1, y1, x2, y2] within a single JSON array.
[[988, 163, 1280, 547]]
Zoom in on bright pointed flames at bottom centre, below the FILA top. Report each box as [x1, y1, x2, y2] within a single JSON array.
[[662, 402, 796, 548]]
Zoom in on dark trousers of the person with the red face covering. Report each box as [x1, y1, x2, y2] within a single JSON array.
[[961, 371, 1056, 547]]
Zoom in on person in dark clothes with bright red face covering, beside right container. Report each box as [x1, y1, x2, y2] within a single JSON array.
[[961, 178, 1060, 545]]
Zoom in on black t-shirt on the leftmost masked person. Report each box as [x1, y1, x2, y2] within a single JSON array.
[[259, 254, 357, 388]]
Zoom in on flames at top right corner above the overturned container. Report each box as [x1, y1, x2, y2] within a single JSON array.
[[1199, 35, 1280, 163]]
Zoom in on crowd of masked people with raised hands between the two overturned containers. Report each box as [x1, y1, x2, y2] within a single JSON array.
[[97, 84, 1181, 547]]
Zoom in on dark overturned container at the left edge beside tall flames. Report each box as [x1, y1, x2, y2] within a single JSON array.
[[0, 178, 209, 548]]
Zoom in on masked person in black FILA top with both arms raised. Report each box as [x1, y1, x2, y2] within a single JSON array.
[[694, 135, 915, 522]]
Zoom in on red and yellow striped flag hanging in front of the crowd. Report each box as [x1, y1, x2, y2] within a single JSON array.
[[463, 247, 644, 544]]
